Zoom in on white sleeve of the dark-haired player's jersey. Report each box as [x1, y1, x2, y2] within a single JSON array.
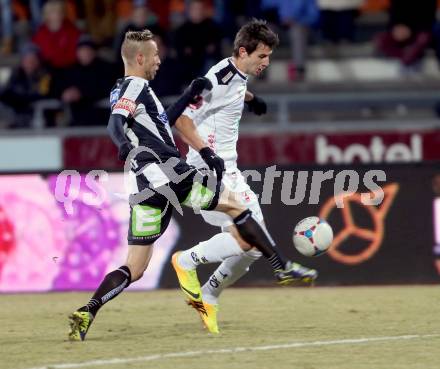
[[183, 72, 224, 124]]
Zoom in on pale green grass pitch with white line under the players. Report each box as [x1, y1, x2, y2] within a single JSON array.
[[0, 286, 440, 369]]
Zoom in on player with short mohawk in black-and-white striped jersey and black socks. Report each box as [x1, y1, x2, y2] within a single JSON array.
[[69, 30, 312, 341]]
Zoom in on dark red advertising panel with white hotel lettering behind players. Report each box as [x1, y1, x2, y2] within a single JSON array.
[[64, 131, 440, 169]]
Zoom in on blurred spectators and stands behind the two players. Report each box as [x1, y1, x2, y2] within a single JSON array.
[[0, 0, 440, 129]]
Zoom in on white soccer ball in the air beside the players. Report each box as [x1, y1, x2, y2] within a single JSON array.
[[293, 217, 333, 256]]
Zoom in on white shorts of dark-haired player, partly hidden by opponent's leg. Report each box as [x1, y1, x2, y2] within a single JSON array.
[[200, 170, 264, 228]]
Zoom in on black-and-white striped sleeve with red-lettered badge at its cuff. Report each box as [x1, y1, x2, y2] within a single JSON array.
[[110, 80, 144, 118]]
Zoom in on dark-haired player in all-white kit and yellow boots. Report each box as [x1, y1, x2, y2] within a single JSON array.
[[173, 20, 317, 333]]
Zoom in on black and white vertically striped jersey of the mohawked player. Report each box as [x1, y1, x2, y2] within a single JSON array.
[[110, 76, 180, 163]]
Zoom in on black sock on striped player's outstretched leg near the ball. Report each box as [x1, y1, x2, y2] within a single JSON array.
[[234, 210, 287, 270]]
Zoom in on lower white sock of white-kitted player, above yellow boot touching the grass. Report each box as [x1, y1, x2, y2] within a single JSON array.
[[202, 249, 262, 304]]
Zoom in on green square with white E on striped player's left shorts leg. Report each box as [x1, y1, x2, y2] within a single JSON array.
[[131, 205, 161, 237]]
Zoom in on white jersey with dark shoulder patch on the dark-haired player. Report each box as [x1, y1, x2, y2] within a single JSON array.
[[183, 58, 247, 173]]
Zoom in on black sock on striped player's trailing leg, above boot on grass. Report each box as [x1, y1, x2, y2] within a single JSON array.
[[80, 265, 131, 316]]
